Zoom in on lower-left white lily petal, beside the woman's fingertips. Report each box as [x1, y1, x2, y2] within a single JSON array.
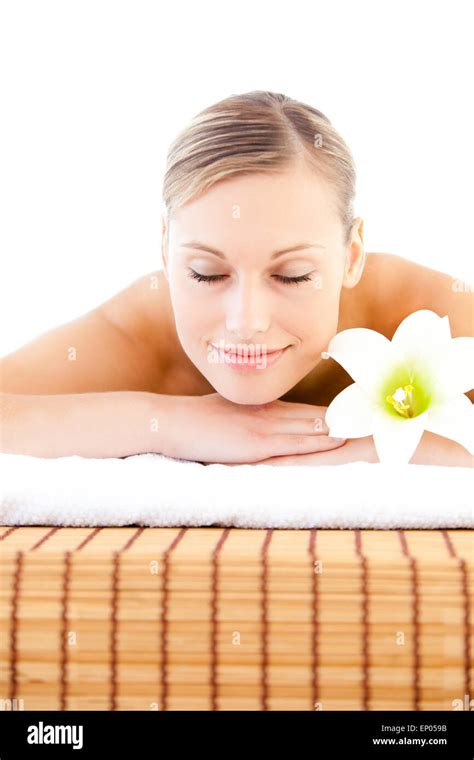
[[325, 383, 374, 438]]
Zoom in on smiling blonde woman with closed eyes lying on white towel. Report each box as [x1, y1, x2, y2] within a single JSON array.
[[1, 91, 474, 466]]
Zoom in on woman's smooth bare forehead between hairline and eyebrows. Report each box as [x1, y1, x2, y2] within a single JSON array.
[[170, 165, 339, 246]]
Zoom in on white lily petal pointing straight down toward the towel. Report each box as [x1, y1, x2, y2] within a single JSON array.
[[373, 411, 428, 464]]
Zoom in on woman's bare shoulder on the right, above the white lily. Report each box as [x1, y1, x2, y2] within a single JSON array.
[[360, 253, 474, 338]]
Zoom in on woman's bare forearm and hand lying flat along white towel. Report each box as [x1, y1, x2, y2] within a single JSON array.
[[0, 391, 344, 463]]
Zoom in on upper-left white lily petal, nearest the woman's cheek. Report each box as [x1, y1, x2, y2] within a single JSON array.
[[323, 327, 392, 393]]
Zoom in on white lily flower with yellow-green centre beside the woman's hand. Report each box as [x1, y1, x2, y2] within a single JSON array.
[[321, 309, 474, 464]]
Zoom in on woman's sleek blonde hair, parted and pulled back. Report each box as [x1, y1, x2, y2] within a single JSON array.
[[163, 90, 356, 244]]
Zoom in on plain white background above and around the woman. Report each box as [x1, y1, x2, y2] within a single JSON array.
[[0, 0, 474, 355]]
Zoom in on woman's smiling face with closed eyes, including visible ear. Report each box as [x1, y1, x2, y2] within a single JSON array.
[[163, 165, 364, 404]]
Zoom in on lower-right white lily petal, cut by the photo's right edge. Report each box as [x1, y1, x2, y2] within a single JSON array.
[[425, 396, 474, 456]]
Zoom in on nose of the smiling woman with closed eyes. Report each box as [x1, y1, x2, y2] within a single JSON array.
[[225, 280, 271, 340]]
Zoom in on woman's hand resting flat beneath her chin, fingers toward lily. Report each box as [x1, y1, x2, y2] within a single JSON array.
[[157, 393, 345, 464]]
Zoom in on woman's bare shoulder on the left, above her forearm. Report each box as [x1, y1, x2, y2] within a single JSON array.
[[0, 272, 176, 394]]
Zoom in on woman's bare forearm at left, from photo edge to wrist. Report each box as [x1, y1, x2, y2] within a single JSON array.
[[0, 391, 167, 458]]
